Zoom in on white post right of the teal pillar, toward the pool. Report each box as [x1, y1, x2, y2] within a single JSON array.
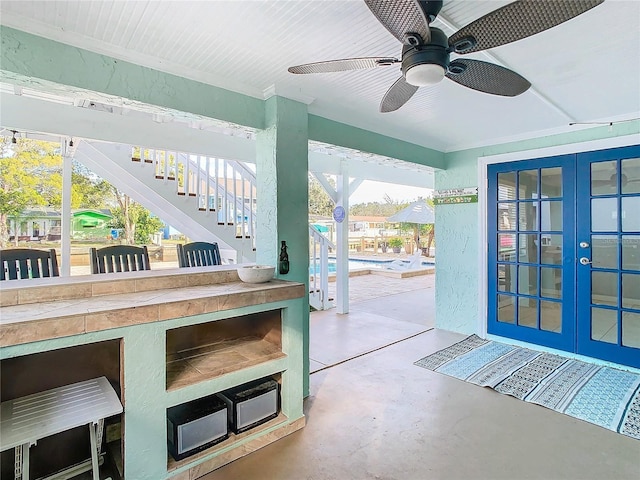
[[336, 160, 349, 313]]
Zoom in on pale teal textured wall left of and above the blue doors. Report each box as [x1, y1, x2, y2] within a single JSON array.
[[435, 121, 640, 334]]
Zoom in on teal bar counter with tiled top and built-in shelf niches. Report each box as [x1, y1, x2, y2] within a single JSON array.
[[0, 266, 305, 480]]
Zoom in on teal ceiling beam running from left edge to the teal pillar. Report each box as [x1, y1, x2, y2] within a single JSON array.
[[0, 26, 264, 128]]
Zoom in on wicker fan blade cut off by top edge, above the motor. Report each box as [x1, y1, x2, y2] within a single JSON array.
[[365, 0, 431, 43]]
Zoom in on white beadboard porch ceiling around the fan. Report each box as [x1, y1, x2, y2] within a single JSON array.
[[0, 0, 640, 151]]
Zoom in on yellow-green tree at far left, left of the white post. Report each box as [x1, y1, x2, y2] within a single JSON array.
[[0, 137, 62, 247]]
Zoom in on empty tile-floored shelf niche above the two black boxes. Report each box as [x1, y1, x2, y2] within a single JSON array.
[[167, 310, 286, 390]]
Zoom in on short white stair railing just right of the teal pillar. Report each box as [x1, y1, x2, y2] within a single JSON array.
[[309, 225, 336, 310]]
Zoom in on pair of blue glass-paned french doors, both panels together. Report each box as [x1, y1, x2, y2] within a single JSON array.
[[487, 146, 640, 367]]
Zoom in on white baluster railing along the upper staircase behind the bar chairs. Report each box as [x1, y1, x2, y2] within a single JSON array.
[[131, 147, 256, 250]]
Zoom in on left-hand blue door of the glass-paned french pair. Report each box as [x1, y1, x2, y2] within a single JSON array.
[[487, 155, 576, 351]]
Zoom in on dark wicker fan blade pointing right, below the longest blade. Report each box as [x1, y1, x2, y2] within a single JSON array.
[[446, 58, 531, 97]]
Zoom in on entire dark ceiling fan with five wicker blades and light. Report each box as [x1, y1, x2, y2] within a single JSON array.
[[289, 0, 604, 113]]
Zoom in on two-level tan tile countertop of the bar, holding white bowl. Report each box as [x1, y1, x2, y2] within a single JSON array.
[[0, 266, 305, 347]]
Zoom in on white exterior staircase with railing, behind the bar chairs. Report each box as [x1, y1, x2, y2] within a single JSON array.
[[75, 141, 256, 263]]
